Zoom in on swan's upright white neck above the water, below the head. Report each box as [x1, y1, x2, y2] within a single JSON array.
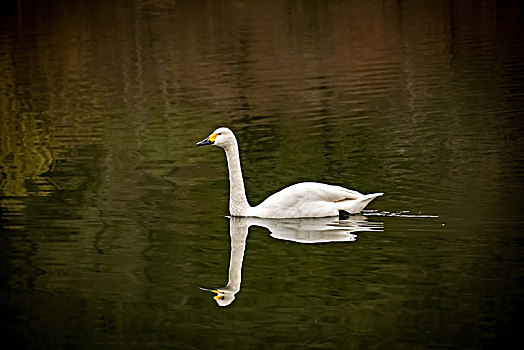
[[224, 142, 250, 216]]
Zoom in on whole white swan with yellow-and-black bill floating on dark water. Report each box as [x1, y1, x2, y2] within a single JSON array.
[[196, 128, 383, 218]]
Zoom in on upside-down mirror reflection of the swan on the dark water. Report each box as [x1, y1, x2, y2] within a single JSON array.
[[201, 215, 383, 306]]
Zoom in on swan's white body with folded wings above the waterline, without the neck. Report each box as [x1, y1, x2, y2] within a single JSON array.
[[248, 182, 380, 218]]
